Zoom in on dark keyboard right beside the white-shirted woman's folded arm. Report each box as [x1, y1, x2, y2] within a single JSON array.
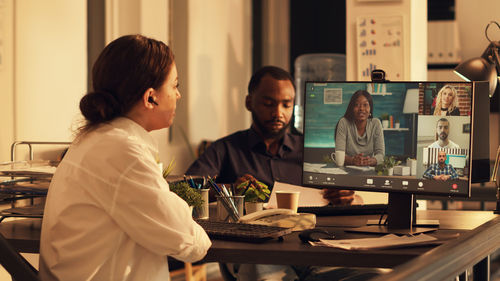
[[196, 220, 292, 242]]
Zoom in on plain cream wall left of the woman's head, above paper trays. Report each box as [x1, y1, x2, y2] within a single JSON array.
[[0, 0, 87, 161]]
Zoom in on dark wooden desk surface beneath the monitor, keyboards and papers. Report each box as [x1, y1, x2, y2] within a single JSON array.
[[0, 210, 497, 267]]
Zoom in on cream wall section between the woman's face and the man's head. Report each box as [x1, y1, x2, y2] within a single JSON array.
[[184, 0, 251, 141]]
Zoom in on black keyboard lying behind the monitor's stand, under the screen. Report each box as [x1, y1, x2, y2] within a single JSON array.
[[297, 204, 387, 216]]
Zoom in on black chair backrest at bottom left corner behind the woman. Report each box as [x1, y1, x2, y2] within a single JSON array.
[[0, 234, 40, 281]]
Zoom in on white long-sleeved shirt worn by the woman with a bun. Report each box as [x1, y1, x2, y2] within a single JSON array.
[[40, 118, 211, 281]]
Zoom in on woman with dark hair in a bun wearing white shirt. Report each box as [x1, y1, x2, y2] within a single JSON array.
[[40, 35, 211, 280]]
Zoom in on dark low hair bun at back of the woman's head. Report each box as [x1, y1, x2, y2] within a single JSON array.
[[80, 91, 121, 124]]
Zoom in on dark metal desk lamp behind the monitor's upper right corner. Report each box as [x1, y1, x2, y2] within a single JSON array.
[[454, 21, 500, 98]]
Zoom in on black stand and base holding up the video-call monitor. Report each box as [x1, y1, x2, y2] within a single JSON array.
[[346, 192, 439, 235]]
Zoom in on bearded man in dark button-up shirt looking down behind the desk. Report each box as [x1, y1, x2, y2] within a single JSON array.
[[186, 66, 354, 204]]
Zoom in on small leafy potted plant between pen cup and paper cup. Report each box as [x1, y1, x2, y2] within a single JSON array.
[[236, 180, 271, 214]]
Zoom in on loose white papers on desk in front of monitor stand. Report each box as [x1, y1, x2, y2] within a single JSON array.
[[309, 234, 437, 250]]
